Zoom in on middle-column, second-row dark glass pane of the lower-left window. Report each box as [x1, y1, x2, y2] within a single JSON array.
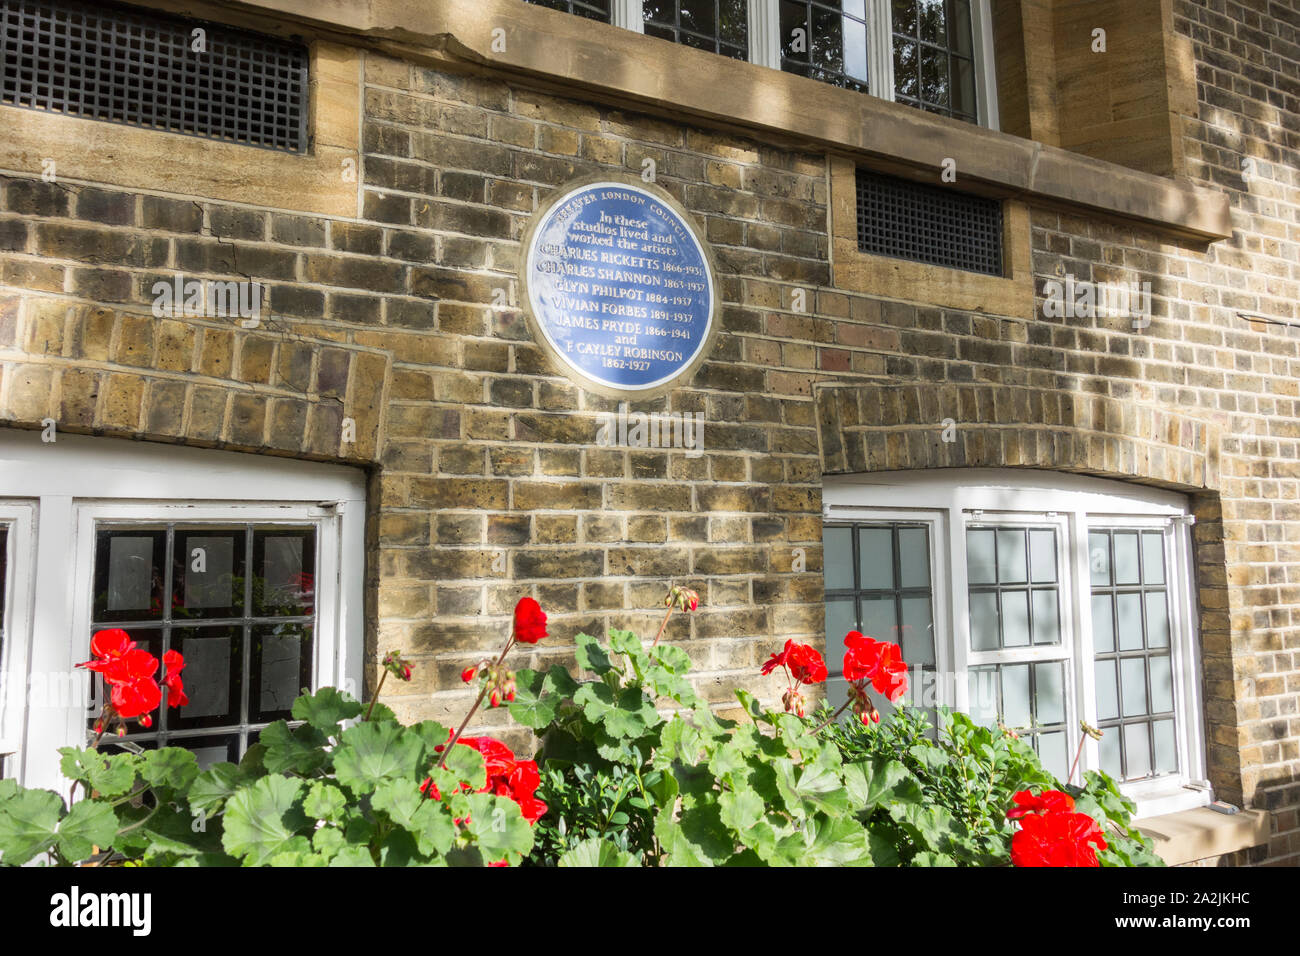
[[168, 627, 243, 728]]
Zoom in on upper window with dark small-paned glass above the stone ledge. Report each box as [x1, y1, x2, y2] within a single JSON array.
[[525, 0, 998, 129]]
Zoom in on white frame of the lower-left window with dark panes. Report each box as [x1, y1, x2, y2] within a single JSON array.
[[0, 432, 365, 792]]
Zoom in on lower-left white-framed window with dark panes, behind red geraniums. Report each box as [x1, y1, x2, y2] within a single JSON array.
[[0, 432, 365, 790]]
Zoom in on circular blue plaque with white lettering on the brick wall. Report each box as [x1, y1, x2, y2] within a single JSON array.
[[524, 182, 716, 393]]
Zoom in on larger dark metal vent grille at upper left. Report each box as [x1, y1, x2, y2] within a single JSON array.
[[0, 0, 308, 152]]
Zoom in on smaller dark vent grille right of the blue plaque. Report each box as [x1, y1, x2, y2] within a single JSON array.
[[858, 169, 1002, 276]]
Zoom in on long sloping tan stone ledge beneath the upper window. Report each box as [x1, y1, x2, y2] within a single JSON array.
[[167, 0, 1232, 241]]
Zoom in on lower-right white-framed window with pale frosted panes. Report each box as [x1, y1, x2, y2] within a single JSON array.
[[823, 470, 1209, 816]]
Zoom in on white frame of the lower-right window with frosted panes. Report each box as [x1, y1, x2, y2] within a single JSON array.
[[822, 468, 1212, 818]]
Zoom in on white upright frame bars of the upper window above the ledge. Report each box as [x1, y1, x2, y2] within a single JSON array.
[[610, 0, 1001, 130]]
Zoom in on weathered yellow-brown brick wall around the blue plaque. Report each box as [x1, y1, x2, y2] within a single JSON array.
[[0, 3, 1300, 862]]
